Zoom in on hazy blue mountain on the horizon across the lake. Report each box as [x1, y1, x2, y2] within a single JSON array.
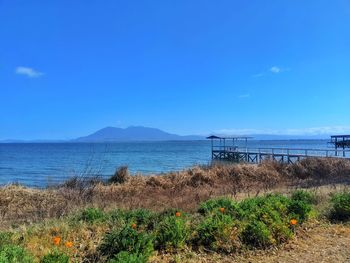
[[73, 126, 205, 142]]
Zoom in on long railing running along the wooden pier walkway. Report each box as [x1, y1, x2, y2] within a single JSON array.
[[212, 146, 350, 158]]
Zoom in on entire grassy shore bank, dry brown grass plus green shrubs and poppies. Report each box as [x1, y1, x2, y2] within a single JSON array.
[[0, 159, 350, 262]]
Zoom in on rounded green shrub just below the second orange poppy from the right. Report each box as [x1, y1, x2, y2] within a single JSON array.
[[193, 214, 239, 253]]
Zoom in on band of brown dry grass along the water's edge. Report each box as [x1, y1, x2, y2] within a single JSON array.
[[0, 158, 350, 228]]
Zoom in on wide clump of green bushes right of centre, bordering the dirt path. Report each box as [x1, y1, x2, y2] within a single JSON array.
[[197, 194, 300, 252]]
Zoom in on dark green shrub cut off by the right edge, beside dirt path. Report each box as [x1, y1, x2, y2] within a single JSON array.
[[330, 192, 350, 221]]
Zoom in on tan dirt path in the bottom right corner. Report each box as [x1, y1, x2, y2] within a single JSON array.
[[154, 223, 350, 263]]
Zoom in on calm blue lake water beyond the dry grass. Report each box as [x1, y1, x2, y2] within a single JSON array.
[[0, 140, 327, 187]]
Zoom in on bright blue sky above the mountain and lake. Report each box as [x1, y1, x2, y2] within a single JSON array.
[[0, 0, 350, 139]]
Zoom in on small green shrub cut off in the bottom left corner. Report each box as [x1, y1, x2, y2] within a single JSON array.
[[0, 245, 34, 263]]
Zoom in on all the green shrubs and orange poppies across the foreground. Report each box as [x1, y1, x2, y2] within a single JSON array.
[[0, 191, 344, 263]]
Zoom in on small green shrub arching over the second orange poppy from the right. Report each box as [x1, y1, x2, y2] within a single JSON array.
[[198, 198, 242, 218]]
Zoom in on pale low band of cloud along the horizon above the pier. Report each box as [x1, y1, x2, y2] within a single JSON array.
[[215, 126, 350, 136]]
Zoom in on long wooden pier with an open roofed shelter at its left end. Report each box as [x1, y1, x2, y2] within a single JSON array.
[[207, 136, 350, 164]]
